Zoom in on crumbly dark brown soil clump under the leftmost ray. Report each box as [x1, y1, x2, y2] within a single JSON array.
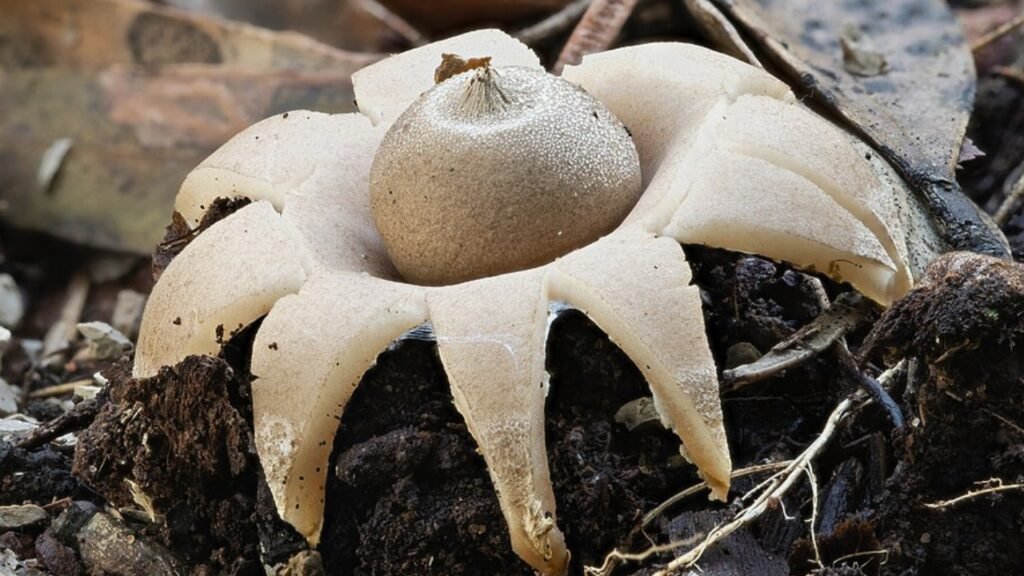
[[74, 357, 261, 574]]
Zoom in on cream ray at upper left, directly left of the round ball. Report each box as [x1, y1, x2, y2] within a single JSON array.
[[175, 111, 395, 278]]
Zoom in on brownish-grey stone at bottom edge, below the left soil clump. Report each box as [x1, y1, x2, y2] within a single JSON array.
[[75, 512, 183, 576]]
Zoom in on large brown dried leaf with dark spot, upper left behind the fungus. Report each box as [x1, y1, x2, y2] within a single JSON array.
[[0, 0, 376, 254]]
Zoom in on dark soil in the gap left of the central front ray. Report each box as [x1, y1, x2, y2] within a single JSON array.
[[319, 340, 530, 575]]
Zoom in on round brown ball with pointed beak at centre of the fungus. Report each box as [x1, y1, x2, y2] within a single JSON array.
[[370, 54, 640, 285]]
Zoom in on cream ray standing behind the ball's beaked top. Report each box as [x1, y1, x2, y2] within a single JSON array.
[[352, 30, 541, 124]]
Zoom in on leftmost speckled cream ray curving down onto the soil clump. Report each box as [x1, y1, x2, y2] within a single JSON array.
[[133, 202, 306, 377]]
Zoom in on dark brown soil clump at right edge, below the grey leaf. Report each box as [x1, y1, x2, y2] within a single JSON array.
[[866, 254, 1024, 574]]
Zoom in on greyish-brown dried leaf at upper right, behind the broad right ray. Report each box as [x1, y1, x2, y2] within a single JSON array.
[[715, 0, 1007, 254]]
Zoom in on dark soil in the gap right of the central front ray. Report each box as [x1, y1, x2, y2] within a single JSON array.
[[545, 311, 699, 574]]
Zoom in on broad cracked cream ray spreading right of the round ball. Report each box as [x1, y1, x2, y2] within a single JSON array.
[[566, 44, 933, 303]]
